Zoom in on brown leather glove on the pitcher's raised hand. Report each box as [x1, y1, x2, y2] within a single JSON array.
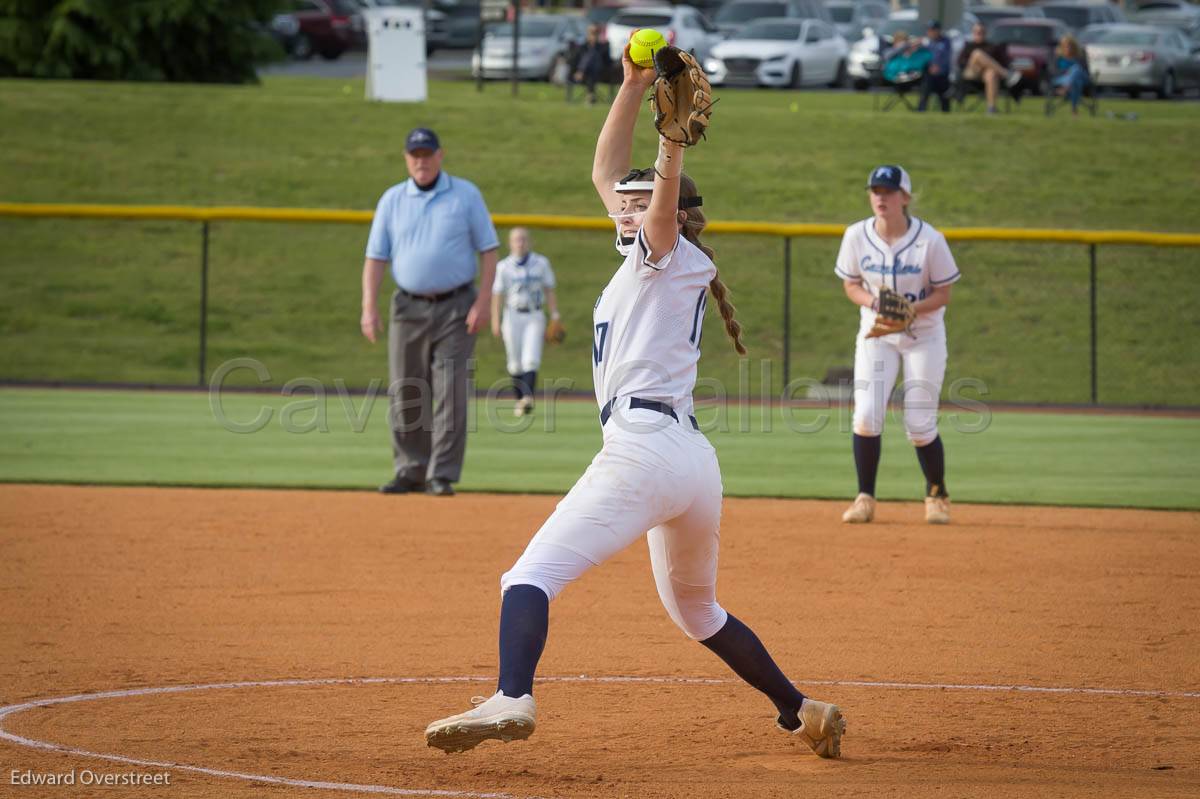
[[650, 46, 713, 148]]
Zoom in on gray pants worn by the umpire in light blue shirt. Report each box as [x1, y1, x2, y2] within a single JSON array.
[[388, 288, 476, 482]]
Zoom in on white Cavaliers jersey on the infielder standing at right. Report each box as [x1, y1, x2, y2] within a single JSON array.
[[834, 217, 962, 336]]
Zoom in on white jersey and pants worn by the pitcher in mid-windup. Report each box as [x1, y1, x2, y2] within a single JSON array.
[[500, 226, 728, 641]]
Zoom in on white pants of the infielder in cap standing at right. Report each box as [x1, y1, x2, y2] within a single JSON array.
[[854, 329, 946, 446]]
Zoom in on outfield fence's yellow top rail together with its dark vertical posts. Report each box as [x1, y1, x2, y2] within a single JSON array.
[[7, 203, 1200, 404]]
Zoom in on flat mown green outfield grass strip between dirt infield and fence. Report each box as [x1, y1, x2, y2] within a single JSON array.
[[0, 386, 1200, 509]]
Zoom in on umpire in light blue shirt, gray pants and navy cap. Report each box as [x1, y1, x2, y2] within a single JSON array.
[[361, 127, 499, 497]]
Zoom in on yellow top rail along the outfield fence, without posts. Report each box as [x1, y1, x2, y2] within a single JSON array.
[[0, 203, 1200, 247]]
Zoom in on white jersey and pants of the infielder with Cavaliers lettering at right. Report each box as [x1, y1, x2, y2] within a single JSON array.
[[834, 217, 961, 446]]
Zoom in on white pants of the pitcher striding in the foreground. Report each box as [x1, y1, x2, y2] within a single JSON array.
[[500, 403, 728, 641]]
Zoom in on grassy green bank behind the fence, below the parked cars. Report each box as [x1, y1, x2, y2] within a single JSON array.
[[0, 78, 1200, 405]]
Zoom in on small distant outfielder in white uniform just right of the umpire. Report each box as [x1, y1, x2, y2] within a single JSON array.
[[492, 228, 558, 416]]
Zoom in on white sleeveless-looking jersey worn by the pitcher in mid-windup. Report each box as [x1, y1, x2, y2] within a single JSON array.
[[592, 224, 716, 410]]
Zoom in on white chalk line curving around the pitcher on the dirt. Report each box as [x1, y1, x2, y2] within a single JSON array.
[[0, 674, 1200, 799]]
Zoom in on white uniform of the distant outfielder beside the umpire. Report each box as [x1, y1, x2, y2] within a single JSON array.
[[492, 252, 554, 374]]
